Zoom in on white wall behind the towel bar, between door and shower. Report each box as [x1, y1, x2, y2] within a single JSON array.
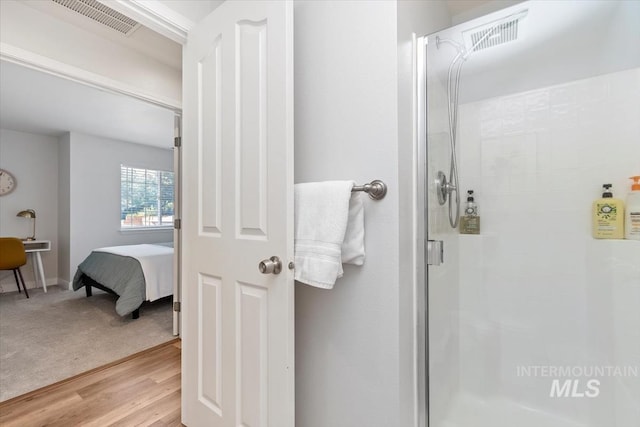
[[294, 1, 399, 427]]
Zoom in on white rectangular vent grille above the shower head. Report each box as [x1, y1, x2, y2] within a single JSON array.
[[462, 9, 528, 59]]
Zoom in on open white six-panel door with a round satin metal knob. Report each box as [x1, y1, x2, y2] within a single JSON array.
[[182, 1, 294, 427]]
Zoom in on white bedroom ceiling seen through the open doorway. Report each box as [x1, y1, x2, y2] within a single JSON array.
[[0, 61, 174, 148]]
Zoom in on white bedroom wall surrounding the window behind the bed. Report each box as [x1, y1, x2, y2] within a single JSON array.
[[63, 132, 173, 280]]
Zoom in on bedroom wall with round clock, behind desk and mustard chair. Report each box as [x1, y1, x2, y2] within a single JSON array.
[[0, 129, 58, 292]]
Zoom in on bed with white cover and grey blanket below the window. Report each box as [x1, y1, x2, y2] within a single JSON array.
[[73, 243, 173, 319]]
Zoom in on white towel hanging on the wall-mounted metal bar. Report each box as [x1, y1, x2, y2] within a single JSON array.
[[294, 181, 364, 289]]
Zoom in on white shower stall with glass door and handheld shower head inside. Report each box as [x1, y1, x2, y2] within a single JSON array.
[[417, 1, 640, 427]]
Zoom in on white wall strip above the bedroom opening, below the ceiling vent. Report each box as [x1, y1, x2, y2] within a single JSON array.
[[0, 0, 182, 106]]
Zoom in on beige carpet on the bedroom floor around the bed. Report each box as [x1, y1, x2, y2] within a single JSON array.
[[0, 286, 174, 401]]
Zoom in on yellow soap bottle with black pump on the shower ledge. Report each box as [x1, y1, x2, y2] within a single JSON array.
[[592, 184, 624, 239]]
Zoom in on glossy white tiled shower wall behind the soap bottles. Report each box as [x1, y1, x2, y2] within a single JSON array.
[[458, 68, 640, 427]]
